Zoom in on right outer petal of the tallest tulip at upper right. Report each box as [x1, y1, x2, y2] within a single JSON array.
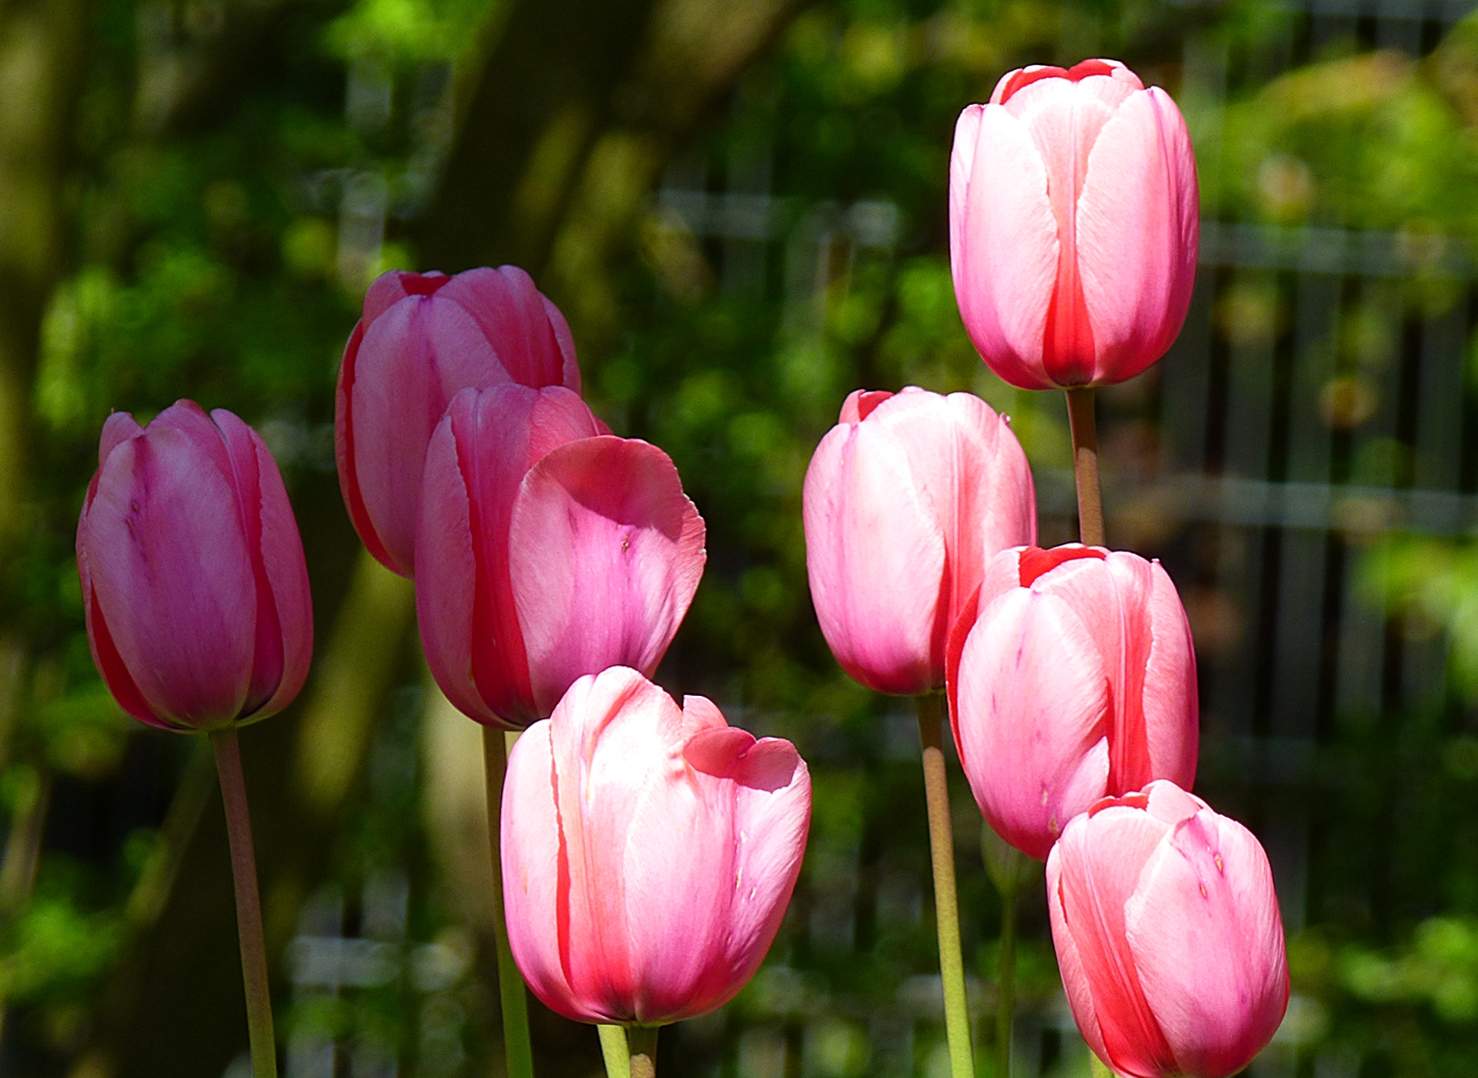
[[1077, 87, 1200, 383]]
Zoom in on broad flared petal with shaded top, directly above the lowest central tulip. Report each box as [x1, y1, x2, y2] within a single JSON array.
[[508, 435, 706, 718]]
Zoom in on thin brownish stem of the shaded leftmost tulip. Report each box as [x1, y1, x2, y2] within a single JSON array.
[[210, 723, 276, 1078]]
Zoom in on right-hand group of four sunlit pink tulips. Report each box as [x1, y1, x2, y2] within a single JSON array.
[[804, 61, 1289, 1078]]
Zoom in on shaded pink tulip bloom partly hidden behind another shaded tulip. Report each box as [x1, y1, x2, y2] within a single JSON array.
[[334, 266, 579, 577]]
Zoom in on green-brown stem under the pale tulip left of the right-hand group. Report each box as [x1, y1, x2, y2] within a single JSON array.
[[916, 692, 975, 1078]]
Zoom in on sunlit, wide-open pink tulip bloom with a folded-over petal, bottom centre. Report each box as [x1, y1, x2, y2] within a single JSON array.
[[503, 667, 811, 1026]]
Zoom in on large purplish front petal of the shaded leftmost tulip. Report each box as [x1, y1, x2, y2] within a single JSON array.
[[78, 425, 256, 728]]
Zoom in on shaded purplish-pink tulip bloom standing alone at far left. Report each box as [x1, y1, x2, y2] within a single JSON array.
[[77, 401, 313, 730]]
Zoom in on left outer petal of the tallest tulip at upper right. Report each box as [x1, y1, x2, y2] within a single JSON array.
[[950, 105, 1060, 389]]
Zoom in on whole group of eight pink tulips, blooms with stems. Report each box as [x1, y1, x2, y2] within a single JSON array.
[[77, 52, 1289, 1078]]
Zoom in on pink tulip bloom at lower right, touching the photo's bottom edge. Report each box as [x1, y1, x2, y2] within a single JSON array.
[[1046, 781, 1289, 1078]]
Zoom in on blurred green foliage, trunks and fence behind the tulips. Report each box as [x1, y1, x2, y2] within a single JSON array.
[[0, 0, 1478, 1078]]
